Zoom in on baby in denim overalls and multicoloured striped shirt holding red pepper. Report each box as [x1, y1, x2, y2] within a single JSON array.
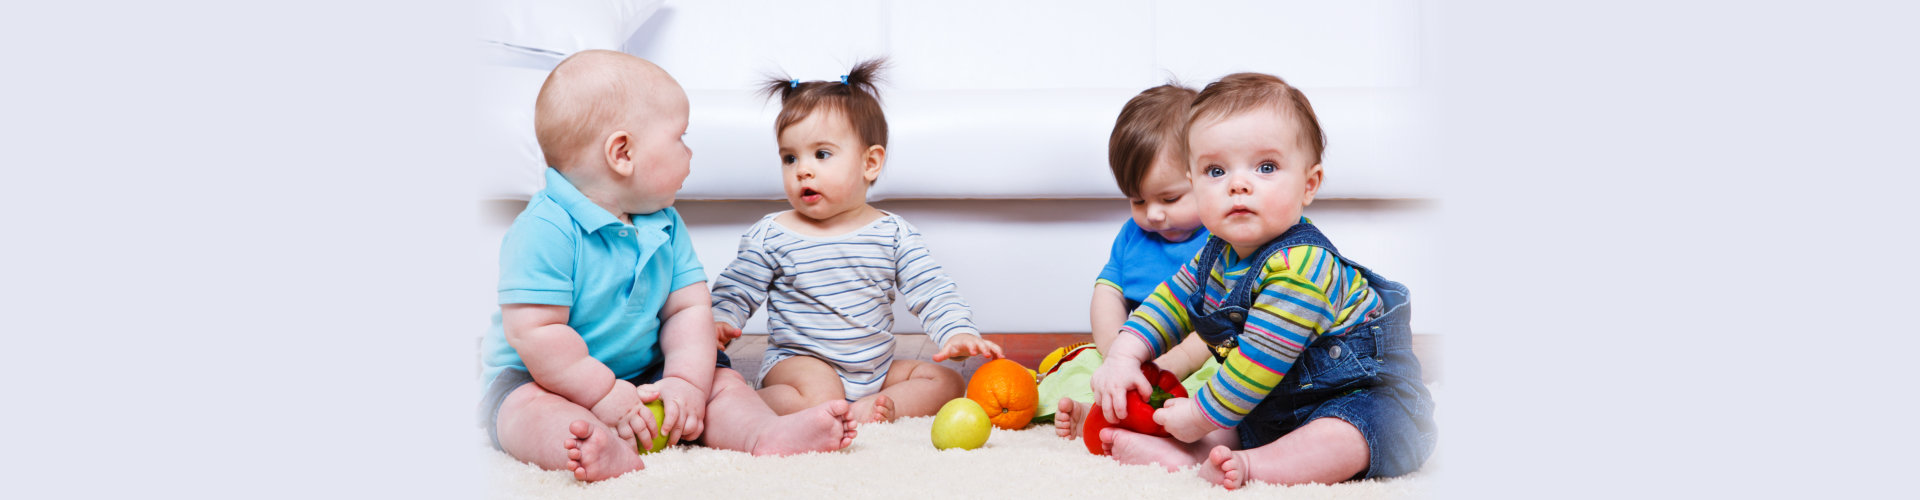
[[1092, 73, 1434, 488]]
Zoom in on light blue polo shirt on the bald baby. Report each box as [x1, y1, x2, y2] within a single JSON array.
[[480, 167, 707, 387]]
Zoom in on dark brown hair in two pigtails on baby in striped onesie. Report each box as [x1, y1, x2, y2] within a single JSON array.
[[760, 58, 887, 146]]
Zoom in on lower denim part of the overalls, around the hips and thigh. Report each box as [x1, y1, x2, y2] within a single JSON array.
[[1238, 321, 1436, 479]]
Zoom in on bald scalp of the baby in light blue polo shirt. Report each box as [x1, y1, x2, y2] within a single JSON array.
[[534, 50, 685, 171]]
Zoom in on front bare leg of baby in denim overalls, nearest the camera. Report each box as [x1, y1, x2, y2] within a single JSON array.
[[1200, 417, 1369, 490]]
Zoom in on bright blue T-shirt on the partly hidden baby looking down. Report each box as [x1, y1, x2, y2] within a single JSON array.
[[1094, 217, 1208, 305]]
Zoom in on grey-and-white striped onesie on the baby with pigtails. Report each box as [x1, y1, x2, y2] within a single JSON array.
[[712, 212, 979, 400]]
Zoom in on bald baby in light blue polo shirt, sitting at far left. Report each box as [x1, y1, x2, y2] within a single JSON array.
[[480, 50, 854, 481]]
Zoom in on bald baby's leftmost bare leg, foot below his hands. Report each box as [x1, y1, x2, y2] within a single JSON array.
[[495, 383, 645, 481]]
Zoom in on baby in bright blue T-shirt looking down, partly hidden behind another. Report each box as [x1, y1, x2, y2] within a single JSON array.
[[1035, 85, 1219, 437]]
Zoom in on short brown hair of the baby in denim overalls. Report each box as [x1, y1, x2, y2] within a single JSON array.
[[1181, 73, 1327, 163]]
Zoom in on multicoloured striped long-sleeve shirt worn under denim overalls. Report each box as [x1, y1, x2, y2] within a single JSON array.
[[1121, 232, 1380, 427]]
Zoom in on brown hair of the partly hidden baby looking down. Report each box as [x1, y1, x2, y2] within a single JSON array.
[[1106, 83, 1194, 198]]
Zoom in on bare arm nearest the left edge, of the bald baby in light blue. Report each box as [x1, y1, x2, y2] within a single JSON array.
[[499, 304, 639, 432]]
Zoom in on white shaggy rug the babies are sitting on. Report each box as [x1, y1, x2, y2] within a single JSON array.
[[482, 390, 1446, 500]]
